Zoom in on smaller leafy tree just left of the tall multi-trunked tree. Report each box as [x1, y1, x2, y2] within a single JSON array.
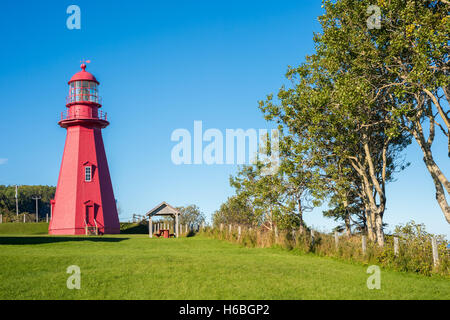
[[230, 134, 323, 230]]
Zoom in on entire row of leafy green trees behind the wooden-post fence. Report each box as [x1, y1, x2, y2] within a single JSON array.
[[213, 0, 450, 246]]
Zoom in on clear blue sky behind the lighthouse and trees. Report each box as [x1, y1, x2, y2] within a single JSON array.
[[0, 0, 450, 236]]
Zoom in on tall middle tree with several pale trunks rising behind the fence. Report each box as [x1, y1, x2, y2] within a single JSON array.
[[260, 0, 409, 246]]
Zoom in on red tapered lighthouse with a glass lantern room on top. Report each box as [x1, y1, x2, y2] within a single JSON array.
[[49, 64, 120, 234]]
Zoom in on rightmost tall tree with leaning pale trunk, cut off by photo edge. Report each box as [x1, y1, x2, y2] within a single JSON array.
[[318, 0, 450, 223]]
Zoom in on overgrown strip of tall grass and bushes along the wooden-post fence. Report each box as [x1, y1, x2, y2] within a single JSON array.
[[204, 221, 450, 276]]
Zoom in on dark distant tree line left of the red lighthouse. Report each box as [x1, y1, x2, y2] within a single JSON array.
[[0, 185, 56, 218]]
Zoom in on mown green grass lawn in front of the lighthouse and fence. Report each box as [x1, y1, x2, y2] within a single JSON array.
[[0, 229, 450, 299]]
